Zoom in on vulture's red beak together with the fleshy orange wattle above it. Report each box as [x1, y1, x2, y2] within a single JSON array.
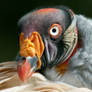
[[17, 32, 44, 82]]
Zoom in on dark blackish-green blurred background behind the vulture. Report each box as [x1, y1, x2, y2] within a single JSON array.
[[0, 0, 92, 62]]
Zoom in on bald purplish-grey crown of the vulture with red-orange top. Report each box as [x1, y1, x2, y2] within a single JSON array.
[[19, 8, 71, 37]]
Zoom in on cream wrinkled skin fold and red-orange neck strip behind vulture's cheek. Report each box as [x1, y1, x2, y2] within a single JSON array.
[[56, 16, 79, 74]]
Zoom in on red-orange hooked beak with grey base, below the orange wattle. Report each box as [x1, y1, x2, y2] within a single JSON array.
[[17, 56, 38, 82]]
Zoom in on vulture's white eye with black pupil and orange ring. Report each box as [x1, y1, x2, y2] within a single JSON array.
[[49, 24, 62, 39]]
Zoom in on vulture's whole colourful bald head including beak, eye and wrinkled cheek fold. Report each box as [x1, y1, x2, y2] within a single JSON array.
[[17, 7, 78, 81]]
